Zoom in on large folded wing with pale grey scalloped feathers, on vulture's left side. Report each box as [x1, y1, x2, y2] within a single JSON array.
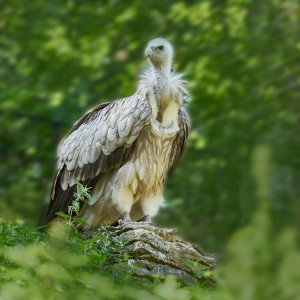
[[42, 95, 151, 224]]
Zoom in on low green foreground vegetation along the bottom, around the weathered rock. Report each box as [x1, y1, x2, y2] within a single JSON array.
[[0, 184, 300, 300]]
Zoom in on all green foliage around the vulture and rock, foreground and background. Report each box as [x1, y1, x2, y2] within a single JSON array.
[[0, 0, 300, 300]]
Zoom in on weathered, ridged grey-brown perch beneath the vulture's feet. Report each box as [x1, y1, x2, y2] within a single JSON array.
[[101, 222, 216, 285]]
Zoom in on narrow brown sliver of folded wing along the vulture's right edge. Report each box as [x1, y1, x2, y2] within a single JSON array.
[[169, 107, 191, 171]]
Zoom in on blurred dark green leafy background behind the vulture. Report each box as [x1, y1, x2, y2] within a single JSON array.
[[0, 0, 300, 253]]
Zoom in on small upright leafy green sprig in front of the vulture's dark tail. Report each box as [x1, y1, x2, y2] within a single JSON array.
[[56, 182, 92, 228]]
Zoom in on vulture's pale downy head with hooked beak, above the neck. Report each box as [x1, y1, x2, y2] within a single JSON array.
[[145, 38, 173, 68]]
